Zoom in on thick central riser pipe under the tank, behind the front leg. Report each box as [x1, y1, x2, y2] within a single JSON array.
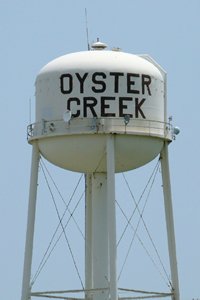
[[91, 173, 109, 300]]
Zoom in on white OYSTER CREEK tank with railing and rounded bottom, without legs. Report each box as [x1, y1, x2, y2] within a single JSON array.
[[29, 48, 171, 173]]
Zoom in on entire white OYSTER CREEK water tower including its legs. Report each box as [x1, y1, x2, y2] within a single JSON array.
[[22, 41, 179, 300]]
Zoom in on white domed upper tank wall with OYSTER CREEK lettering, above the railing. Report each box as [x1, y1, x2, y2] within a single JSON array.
[[36, 51, 164, 122]]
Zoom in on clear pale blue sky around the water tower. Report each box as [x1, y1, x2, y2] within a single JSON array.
[[0, 0, 200, 300]]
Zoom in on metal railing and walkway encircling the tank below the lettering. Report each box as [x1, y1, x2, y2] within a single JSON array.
[[27, 115, 174, 141]]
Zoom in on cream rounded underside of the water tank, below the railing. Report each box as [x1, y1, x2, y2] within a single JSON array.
[[35, 134, 163, 173]]
